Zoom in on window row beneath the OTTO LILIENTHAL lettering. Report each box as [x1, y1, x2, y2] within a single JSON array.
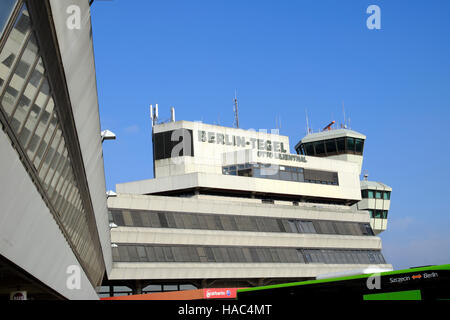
[[222, 163, 339, 186]]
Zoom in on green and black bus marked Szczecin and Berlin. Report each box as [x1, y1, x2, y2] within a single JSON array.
[[237, 264, 450, 302]]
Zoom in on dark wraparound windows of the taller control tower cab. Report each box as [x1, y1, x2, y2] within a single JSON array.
[[296, 137, 364, 157]]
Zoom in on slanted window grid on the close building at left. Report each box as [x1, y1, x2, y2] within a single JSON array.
[[0, 5, 103, 283]]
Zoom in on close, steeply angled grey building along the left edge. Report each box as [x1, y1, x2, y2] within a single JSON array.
[[0, 0, 112, 300]]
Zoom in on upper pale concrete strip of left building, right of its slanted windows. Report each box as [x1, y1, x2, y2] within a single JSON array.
[[50, 0, 112, 272]]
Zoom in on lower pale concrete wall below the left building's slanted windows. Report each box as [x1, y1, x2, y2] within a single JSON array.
[[0, 121, 98, 299]]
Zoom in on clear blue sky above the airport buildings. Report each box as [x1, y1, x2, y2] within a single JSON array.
[[91, 0, 450, 269]]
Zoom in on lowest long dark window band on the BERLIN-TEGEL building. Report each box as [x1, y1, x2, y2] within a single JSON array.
[[113, 244, 386, 264]]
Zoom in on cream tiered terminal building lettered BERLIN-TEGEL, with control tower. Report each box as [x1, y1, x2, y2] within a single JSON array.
[[104, 119, 392, 293]]
